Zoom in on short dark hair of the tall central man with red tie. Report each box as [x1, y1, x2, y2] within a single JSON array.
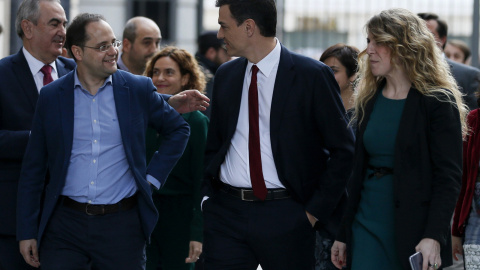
[[215, 0, 277, 37]]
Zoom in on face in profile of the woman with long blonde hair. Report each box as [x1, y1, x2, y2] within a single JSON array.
[[367, 33, 394, 77]]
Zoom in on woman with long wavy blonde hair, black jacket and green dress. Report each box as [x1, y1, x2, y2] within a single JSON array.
[[331, 9, 467, 270]]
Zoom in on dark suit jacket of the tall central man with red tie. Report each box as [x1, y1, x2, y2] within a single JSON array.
[[205, 46, 354, 232]]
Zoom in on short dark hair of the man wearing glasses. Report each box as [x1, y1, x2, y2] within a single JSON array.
[[65, 13, 106, 60]]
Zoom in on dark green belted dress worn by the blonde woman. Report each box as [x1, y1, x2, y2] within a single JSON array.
[[352, 92, 406, 270]]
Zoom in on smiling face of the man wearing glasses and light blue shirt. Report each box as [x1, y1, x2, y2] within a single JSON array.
[[76, 20, 118, 79]]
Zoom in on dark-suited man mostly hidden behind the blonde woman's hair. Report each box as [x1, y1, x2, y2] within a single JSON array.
[[418, 13, 480, 110]]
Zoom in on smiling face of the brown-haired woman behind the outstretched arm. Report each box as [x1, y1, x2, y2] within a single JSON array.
[[152, 56, 189, 95]]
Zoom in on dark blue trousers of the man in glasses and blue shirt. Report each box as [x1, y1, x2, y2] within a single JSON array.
[[39, 201, 146, 270]]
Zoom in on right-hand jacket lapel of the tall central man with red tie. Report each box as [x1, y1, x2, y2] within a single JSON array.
[[270, 45, 296, 146]]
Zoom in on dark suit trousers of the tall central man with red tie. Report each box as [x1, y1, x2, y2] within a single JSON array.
[[203, 191, 315, 270]]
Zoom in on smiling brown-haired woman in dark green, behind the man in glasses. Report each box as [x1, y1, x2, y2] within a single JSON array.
[[144, 46, 208, 270]]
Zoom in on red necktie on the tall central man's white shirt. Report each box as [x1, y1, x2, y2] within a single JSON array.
[[248, 65, 267, 200]]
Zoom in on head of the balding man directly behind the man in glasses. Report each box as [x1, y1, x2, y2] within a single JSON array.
[[118, 16, 162, 75]]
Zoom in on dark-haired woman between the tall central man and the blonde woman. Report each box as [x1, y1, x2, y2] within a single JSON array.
[[320, 43, 359, 111]]
